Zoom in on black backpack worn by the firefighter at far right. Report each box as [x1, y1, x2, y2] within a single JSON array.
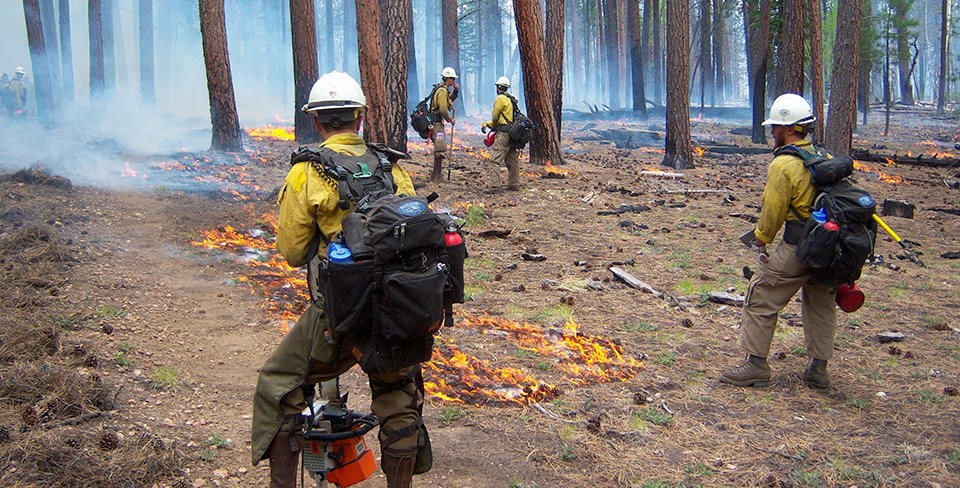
[[775, 145, 877, 285]]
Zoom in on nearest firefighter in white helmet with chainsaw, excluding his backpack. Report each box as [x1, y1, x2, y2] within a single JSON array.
[[251, 71, 429, 488]]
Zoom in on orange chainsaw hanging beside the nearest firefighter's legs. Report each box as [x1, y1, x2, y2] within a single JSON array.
[[301, 384, 379, 488]]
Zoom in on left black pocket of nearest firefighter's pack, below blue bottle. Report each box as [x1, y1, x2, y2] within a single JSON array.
[[318, 261, 374, 333]]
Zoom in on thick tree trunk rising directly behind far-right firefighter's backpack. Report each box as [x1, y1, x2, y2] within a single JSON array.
[[824, 0, 863, 154]]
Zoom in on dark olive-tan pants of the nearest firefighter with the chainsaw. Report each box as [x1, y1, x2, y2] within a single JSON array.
[[251, 304, 423, 465]]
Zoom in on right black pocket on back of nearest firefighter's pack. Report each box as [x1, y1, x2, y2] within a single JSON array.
[[379, 267, 447, 341]]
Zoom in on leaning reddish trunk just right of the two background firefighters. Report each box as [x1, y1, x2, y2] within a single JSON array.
[[513, 0, 563, 165]]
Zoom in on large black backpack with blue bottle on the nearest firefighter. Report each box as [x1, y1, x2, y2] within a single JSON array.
[[295, 146, 467, 374]]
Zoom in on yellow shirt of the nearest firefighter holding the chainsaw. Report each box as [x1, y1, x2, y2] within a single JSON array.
[[277, 134, 416, 267]]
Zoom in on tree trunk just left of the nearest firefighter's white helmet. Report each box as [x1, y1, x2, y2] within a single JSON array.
[[290, 0, 320, 144]]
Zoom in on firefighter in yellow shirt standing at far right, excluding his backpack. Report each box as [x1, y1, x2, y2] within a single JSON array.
[[720, 93, 837, 388]]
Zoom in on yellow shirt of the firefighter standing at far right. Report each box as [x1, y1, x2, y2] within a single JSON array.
[[754, 139, 817, 243]]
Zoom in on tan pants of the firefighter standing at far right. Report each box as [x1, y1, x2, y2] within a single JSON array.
[[740, 242, 837, 360]]
